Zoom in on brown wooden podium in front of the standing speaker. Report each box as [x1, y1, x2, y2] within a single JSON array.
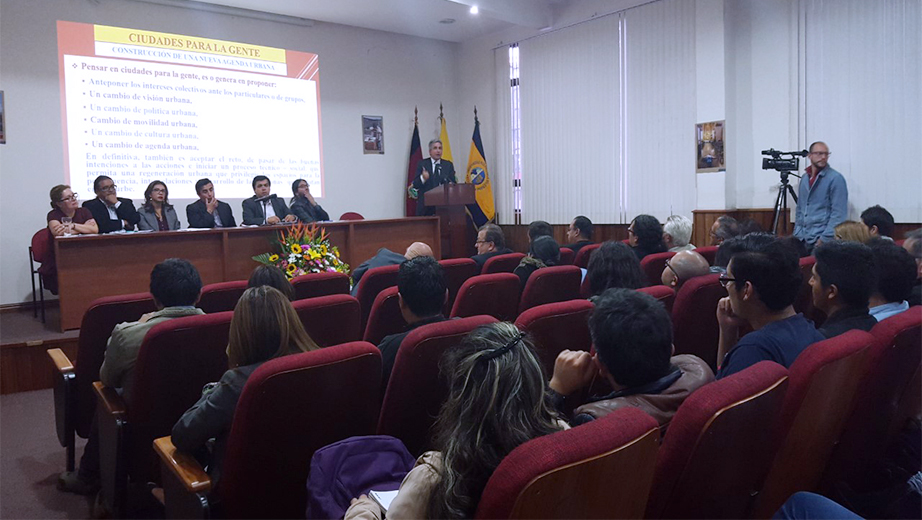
[[425, 184, 476, 258]]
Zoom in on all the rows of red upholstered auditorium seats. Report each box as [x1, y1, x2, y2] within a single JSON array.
[[49, 248, 922, 518]]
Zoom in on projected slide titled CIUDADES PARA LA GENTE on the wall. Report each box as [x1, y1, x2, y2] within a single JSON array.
[[58, 21, 323, 199]]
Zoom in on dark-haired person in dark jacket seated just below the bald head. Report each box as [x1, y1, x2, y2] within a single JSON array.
[[378, 256, 448, 388]]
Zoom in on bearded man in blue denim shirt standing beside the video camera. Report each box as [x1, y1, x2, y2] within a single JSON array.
[[794, 141, 848, 252]]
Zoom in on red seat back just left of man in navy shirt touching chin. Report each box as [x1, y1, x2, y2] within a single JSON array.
[[672, 274, 727, 372]]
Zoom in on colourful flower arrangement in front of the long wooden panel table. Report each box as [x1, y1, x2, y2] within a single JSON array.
[[253, 223, 349, 279]]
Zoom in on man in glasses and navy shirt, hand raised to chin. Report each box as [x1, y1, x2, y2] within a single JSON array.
[[717, 240, 824, 379]]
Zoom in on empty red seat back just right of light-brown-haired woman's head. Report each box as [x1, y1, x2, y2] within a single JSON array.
[[291, 294, 362, 347]]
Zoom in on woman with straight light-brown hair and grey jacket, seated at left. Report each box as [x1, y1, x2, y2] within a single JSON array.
[[172, 285, 320, 485]]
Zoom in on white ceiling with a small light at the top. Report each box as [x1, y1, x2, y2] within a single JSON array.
[[188, 0, 560, 42]]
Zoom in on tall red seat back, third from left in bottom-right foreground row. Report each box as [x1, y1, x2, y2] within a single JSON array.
[[753, 330, 877, 518]]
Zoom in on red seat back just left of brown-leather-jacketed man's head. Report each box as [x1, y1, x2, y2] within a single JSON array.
[[515, 300, 594, 379]]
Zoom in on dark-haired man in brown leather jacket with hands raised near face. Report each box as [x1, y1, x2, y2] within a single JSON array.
[[549, 289, 714, 430]]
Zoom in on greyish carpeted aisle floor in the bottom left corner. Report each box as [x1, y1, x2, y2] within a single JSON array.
[[0, 390, 91, 519]]
